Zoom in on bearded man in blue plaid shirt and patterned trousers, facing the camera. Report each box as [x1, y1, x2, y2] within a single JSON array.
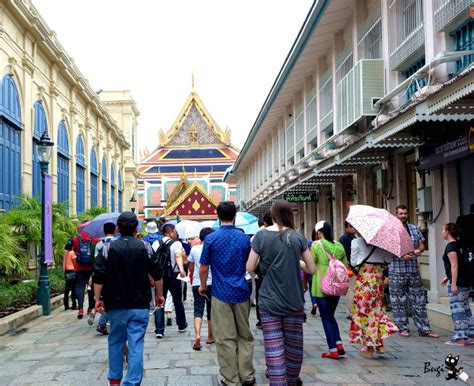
[[388, 205, 439, 338]]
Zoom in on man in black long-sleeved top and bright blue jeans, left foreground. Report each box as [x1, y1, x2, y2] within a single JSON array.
[[93, 212, 164, 385]]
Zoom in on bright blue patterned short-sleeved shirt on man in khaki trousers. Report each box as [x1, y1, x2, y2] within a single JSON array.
[[200, 225, 250, 304]]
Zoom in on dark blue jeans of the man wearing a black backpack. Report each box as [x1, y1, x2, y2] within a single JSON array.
[[155, 273, 188, 334]]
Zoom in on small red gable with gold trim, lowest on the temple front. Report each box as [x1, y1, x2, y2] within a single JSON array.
[[164, 181, 217, 220]]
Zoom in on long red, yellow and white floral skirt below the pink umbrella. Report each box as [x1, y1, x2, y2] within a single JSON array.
[[349, 264, 398, 347]]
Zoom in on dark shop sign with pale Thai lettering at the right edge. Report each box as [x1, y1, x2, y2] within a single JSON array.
[[419, 127, 474, 170]]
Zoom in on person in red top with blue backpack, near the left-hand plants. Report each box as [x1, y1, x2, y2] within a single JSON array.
[[72, 234, 99, 319]]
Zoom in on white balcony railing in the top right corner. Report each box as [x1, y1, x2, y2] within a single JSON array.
[[433, 0, 472, 32]]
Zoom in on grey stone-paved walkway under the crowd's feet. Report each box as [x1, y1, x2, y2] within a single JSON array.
[[0, 292, 474, 385]]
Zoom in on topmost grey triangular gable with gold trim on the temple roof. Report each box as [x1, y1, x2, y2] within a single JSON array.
[[159, 89, 230, 147]]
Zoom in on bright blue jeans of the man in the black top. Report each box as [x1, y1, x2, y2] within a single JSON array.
[[107, 309, 149, 385]]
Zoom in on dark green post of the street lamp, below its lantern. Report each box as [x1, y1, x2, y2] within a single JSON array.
[[37, 162, 51, 316]]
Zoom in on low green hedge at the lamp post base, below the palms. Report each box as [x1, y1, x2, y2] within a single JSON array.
[[0, 268, 64, 311]]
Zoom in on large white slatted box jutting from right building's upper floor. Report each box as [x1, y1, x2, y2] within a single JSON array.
[[335, 59, 385, 133]]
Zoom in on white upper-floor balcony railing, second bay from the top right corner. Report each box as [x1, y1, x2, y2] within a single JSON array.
[[389, 0, 425, 71]]
